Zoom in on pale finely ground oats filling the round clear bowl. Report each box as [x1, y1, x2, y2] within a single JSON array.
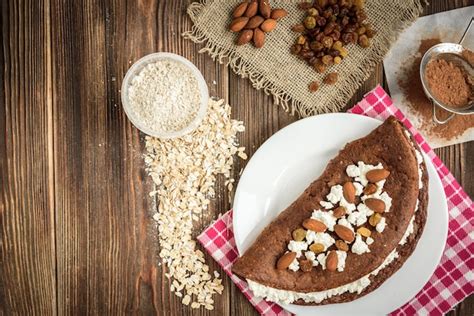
[[128, 59, 201, 133]]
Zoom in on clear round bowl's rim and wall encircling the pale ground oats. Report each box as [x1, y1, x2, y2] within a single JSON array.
[[121, 53, 209, 138]]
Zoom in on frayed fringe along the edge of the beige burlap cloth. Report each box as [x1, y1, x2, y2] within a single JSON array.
[[181, 0, 428, 117]]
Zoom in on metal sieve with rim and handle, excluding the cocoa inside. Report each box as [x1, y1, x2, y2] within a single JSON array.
[[420, 19, 474, 124]]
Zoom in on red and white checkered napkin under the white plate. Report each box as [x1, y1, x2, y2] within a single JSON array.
[[198, 86, 474, 315]]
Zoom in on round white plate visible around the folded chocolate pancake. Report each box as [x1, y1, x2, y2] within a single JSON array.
[[233, 113, 448, 316]]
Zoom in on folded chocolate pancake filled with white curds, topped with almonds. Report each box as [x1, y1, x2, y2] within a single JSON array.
[[232, 117, 428, 305]]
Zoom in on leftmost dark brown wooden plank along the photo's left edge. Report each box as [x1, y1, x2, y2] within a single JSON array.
[[0, 1, 56, 315]]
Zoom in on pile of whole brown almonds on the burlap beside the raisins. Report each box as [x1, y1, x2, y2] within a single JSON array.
[[229, 0, 288, 48]]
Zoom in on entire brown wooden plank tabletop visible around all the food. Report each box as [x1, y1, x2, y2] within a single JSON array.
[[0, 0, 474, 315]]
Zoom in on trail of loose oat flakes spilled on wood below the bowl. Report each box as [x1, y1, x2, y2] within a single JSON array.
[[145, 99, 247, 310]]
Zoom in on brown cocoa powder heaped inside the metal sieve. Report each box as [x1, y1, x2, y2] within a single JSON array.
[[425, 59, 472, 108]]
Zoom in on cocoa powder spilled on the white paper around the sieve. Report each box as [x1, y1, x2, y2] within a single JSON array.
[[398, 38, 474, 140]]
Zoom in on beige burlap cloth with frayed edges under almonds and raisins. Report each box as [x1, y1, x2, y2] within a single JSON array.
[[183, 0, 422, 117]]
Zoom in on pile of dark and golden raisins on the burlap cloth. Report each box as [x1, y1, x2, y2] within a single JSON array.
[[291, 0, 375, 92]]
